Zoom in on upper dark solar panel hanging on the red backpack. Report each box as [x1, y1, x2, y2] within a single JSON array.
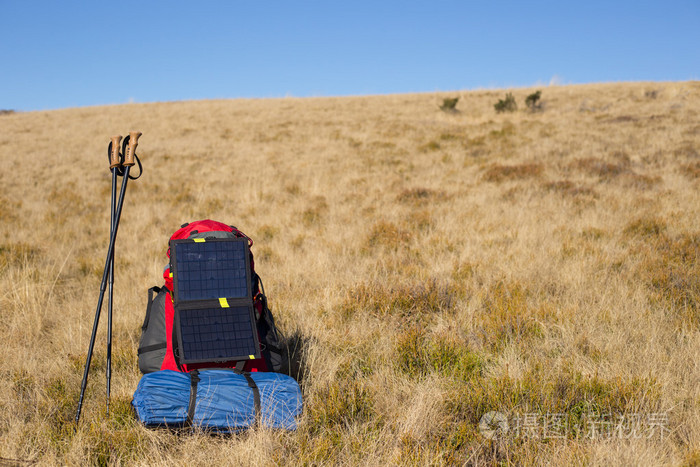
[[171, 238, 251, 302]]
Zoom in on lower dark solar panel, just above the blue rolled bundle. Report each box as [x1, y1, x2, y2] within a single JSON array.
[[175, 305, 260, 363]]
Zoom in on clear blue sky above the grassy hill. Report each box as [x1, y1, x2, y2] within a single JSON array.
[[0, 0, 700, 111]]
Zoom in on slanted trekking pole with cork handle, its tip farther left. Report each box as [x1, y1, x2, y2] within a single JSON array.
[[75, 131, 141, 429]]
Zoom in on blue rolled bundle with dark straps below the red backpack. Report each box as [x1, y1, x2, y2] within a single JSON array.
[[131, 369, 302, 433]]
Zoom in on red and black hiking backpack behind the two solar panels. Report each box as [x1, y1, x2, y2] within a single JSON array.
[[138, 220, 289, 374]]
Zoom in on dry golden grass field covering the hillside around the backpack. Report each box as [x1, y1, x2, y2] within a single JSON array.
[[0, 82, 700, 465]]
